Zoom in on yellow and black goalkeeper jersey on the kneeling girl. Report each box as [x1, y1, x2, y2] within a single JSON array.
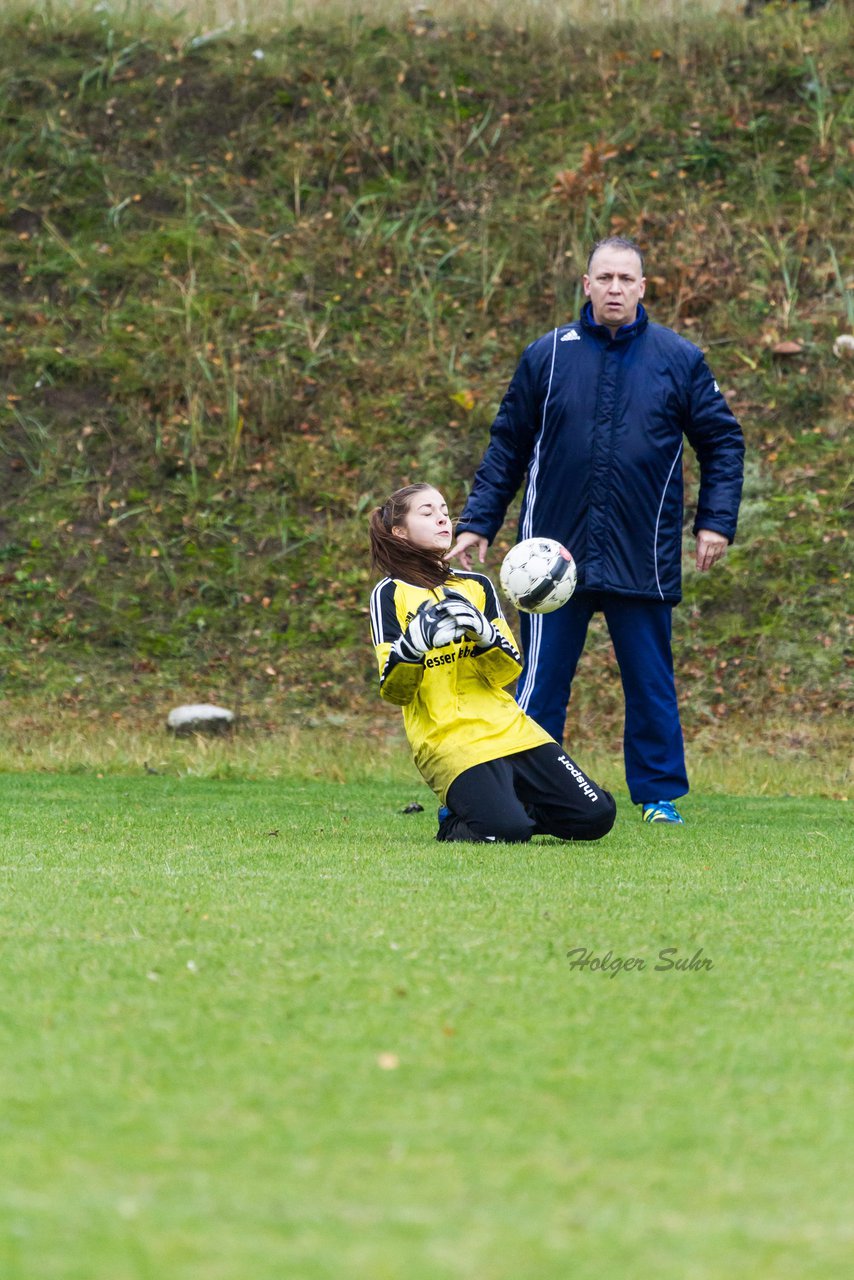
[[370, 572, 553, 804]]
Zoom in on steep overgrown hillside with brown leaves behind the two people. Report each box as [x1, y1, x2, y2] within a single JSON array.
[[0, 4, 854, 723]]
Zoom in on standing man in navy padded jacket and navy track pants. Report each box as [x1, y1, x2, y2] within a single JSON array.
[[448, 237, 744, 822]]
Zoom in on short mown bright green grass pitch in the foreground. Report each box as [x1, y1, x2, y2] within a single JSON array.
[[0, 773, 853, 1280]]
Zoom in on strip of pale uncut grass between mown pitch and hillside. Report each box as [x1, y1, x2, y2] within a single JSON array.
[[0, 695, 854, 808]]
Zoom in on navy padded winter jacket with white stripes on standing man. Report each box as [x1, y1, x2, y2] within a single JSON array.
[[457, 302, 744, 602]]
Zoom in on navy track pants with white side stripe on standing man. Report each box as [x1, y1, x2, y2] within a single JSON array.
[[516, 591, 688, 804]]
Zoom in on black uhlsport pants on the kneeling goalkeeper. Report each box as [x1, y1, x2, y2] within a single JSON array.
[[437, 742, 617, 844]]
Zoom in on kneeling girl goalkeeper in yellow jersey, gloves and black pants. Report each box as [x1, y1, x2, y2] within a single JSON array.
[[370, 484, 616, 841]]
